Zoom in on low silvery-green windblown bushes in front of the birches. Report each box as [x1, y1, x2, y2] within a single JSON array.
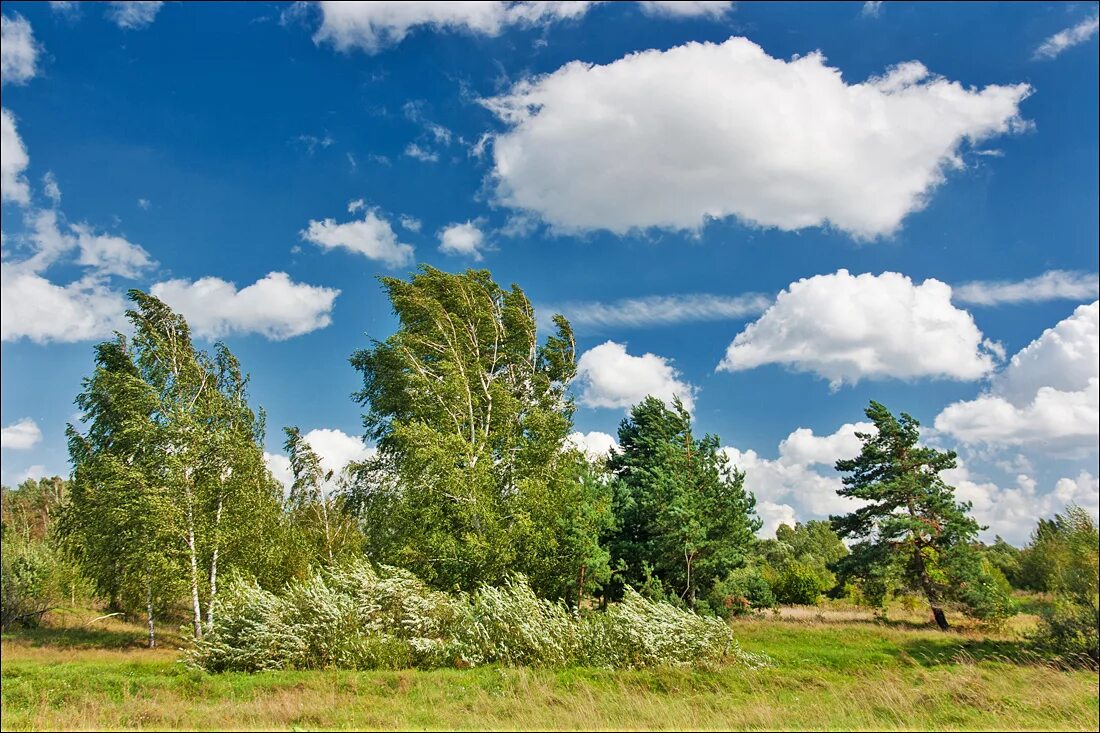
[[189, 561, 767, 671]]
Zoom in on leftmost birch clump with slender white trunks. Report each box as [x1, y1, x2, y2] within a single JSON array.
[[58, 291, 281, 642]]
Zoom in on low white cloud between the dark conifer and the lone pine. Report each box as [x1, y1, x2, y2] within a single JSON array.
[[723, 423, 875, 536]]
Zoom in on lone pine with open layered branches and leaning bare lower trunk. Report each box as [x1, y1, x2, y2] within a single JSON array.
[[831, 402, 1008, 630]]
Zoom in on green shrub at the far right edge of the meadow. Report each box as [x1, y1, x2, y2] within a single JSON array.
[[1023, 506, 1100, 668]]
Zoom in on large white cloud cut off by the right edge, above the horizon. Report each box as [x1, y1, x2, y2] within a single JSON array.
[[935, 303, 1100, 453]]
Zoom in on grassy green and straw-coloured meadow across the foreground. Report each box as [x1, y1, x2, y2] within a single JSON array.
[[2, 609, 1098, 731]]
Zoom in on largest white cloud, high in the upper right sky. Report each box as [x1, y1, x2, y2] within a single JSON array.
[[485, 37, 1030, 238]]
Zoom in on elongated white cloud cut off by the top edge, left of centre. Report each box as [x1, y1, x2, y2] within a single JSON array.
[[314, 0, 593, 54]]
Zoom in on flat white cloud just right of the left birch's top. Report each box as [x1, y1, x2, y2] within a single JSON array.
[[152, 272, 340, 341]]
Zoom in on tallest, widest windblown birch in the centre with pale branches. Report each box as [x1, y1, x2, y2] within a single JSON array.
[[350, 266, 609, 597]]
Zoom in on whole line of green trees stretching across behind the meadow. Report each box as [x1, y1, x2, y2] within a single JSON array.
[[4, 266, 1096, 664]]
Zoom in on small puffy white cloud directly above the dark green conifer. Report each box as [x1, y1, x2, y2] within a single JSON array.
[[576, 341, 696, 412]]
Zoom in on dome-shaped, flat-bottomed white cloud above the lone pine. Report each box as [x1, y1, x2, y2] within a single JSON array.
[[718, 270, 999, 389]]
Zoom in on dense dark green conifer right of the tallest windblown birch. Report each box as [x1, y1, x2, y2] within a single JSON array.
[[608, 396, 760, 608]]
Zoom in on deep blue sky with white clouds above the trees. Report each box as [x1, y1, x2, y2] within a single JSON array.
[[0, 2, 1100, 540]]
